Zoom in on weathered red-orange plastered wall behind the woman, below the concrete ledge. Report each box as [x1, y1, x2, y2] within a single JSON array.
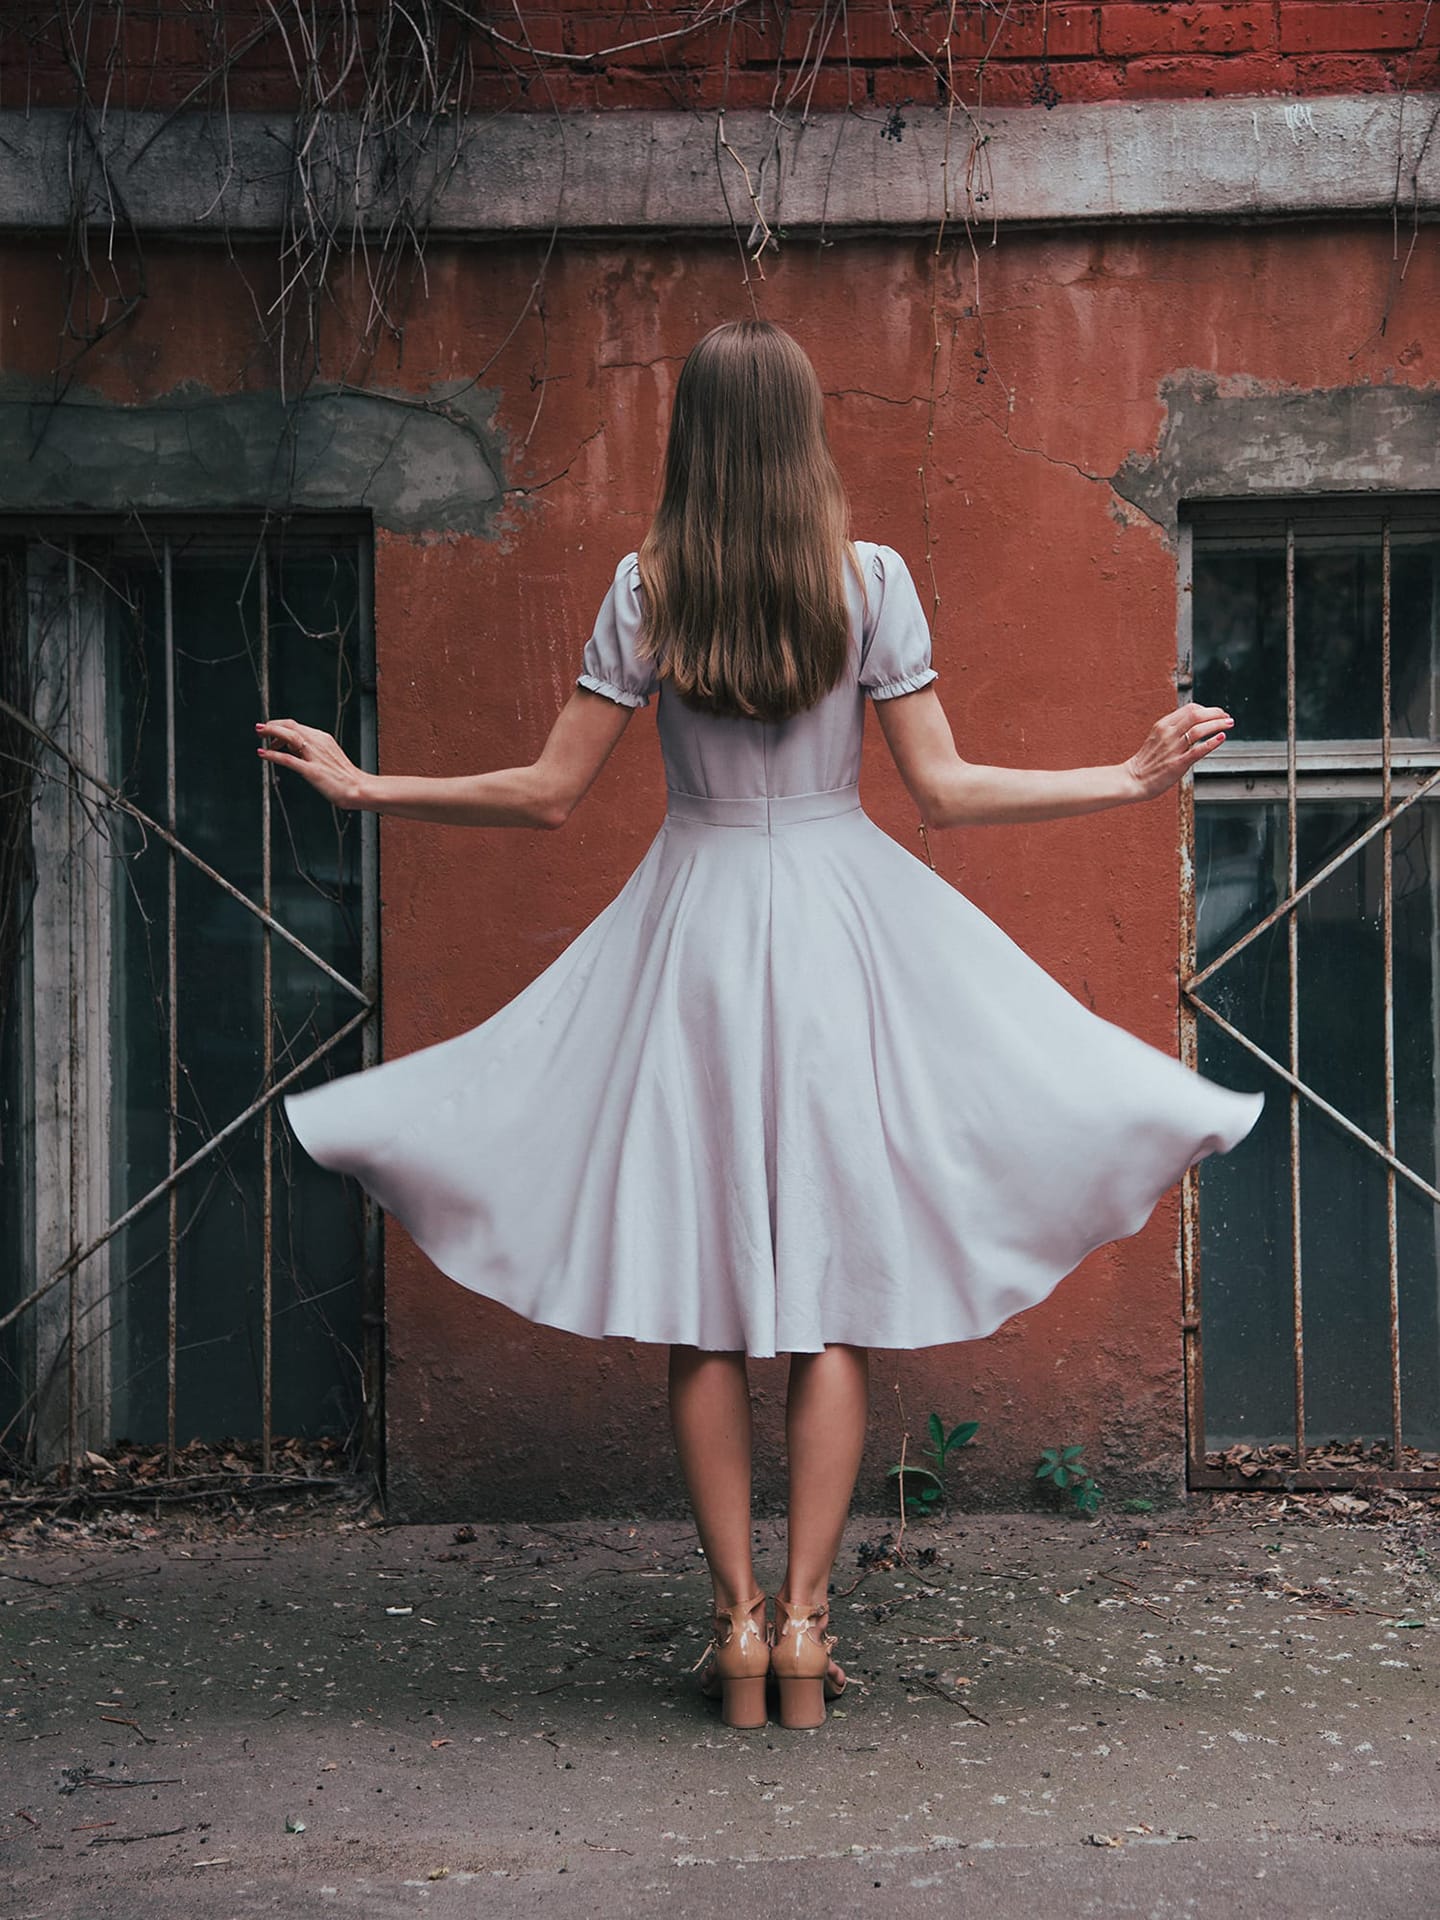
[[2, 214, 1440, 1515]]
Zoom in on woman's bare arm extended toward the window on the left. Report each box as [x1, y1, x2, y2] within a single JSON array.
[[255, 687, 634, 829]]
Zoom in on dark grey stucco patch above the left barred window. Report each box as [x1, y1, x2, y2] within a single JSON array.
[[0, 376, 505, 534]]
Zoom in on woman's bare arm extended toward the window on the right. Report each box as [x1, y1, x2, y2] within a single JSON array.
[[874, 687, 1235, 828]]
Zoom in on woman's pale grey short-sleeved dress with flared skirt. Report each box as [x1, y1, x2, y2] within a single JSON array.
[[286, 543, 1261, 1354]]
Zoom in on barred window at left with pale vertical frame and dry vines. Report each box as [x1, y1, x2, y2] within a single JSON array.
[[0, 520, 378, 1469]]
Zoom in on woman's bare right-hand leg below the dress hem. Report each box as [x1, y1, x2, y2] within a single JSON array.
[[780, 1346, 870, 1635]]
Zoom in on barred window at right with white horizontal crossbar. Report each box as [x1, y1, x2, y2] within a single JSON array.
[[1181, 499, 1440, 1482]]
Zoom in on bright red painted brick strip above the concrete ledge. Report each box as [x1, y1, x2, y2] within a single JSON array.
[[0, 0, 1440, 113]]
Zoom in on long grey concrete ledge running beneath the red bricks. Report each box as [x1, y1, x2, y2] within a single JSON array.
[[0, 94, 1440, 238]]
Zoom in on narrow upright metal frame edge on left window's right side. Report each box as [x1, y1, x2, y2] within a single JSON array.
[[355, 534, 386, 1486]]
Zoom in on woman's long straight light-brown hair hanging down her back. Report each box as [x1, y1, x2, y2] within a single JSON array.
[[639, 321, 858, 720]]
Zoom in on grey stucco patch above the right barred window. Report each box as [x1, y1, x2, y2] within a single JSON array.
[[1110, 369, 1440, 528]]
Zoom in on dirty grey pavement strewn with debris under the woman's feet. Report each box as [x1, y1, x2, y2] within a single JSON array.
[[0, 1496, 1440, 1920]]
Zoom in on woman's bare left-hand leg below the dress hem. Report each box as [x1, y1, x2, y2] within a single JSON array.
[[670, 1346, 755, 1607]]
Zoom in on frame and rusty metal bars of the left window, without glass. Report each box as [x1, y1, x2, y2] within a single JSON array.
[[0, 513, 384, 1476]]
